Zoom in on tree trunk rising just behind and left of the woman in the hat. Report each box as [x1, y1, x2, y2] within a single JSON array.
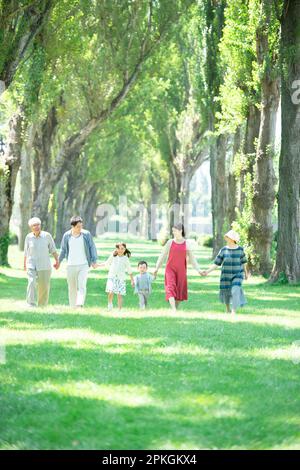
[[210, 134, 227, 256]]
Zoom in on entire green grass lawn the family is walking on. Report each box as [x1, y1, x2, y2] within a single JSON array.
[[0, 239, 300, 449]]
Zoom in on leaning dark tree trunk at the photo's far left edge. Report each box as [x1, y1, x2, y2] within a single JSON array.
[[0, 110, 23, 266]]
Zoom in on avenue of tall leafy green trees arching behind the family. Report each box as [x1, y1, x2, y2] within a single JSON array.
[[0, 0, 300, 283]]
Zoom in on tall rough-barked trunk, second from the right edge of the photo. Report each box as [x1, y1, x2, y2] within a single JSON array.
[[249, 0, 280, 275]]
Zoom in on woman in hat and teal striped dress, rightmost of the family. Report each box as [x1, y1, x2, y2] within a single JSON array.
[[202, 230, 248, 315]]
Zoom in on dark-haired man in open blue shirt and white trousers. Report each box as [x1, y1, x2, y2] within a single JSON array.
[[59, 216, 98, 307]]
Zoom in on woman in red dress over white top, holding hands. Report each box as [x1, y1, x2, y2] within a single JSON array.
[[153, 224, 202, 311]]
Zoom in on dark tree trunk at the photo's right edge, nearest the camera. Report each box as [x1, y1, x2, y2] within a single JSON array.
[[270, 0, 300, 284]]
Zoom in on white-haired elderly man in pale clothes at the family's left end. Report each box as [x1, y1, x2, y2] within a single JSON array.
[[24, 217, 59, 307]]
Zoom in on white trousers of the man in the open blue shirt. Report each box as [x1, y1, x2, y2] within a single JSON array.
[[67, 264, 89, 307]]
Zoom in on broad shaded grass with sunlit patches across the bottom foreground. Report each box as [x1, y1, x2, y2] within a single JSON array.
[[0, 328, 300, 449]]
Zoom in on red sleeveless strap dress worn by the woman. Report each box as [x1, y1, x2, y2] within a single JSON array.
[[165, 240, 188, 300]]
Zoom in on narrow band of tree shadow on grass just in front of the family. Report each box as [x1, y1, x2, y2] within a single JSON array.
[[0, 311, 300, 350]]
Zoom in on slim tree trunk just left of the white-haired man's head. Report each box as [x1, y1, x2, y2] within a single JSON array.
[[19, 126, 34, 251]]
